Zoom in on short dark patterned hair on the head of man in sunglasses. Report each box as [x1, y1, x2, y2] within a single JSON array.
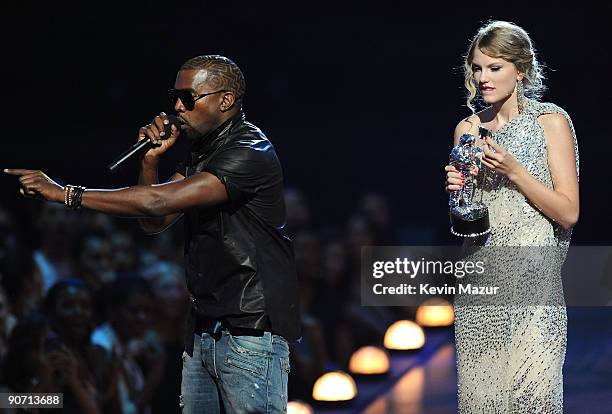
[[180, 55, 246, 100]]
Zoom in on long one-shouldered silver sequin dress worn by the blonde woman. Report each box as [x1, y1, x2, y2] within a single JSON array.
[[455, 100, 578, 414]]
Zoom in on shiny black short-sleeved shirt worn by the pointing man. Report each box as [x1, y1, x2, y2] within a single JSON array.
[[176, 112, 299, 351]]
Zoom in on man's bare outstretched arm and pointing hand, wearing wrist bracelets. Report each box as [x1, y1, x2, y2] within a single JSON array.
[[4, 169, 228, 217]]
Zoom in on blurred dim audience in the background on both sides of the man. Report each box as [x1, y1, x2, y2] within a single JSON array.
[[0, 188, 414, 414]]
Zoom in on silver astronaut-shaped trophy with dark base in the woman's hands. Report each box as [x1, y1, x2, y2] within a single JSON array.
[[449, 127, 491, 237]]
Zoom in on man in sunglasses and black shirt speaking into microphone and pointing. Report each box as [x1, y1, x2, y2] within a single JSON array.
[[5, 55, 299, 413]]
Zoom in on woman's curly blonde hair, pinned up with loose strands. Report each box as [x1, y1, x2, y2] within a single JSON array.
[[463, 21, 546, 112]]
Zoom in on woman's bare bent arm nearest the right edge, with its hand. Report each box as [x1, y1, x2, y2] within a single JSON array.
[[483, 113, 580, 229]]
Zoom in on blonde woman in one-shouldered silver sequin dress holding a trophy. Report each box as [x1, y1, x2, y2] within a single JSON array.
[[445, 21, 579, 413]]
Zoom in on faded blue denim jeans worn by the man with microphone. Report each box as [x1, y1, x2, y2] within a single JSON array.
[[180, 329, 289, 414]]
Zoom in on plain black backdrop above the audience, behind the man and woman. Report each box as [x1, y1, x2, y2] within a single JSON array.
[[0, 2, 612, 244]]
